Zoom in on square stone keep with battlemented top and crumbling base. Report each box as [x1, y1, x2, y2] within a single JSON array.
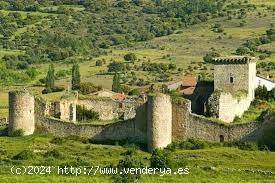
[[207, 57, 256, 122]]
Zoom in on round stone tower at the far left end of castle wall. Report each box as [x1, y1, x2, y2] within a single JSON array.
[[9, 91, 35, 135]]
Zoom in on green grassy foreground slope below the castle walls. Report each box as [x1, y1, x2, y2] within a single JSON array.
[[0, 135, 275, 182]]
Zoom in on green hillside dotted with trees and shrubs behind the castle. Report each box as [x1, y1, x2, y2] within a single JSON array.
[[0, 0, 274, 88]]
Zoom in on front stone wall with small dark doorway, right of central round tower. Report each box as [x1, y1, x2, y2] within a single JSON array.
[[172, 101, 261, 142]]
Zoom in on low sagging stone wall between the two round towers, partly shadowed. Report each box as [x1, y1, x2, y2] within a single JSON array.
[[36, 118, 146, 143]]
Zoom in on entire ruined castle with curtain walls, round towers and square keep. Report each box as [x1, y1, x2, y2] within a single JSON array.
[[3, 57, 274, 151]]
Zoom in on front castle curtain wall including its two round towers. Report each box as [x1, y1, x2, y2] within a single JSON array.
[[5, 91, 270, 151]]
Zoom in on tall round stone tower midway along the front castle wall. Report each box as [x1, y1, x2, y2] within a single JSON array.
[[147, 93, 172, 151]]
